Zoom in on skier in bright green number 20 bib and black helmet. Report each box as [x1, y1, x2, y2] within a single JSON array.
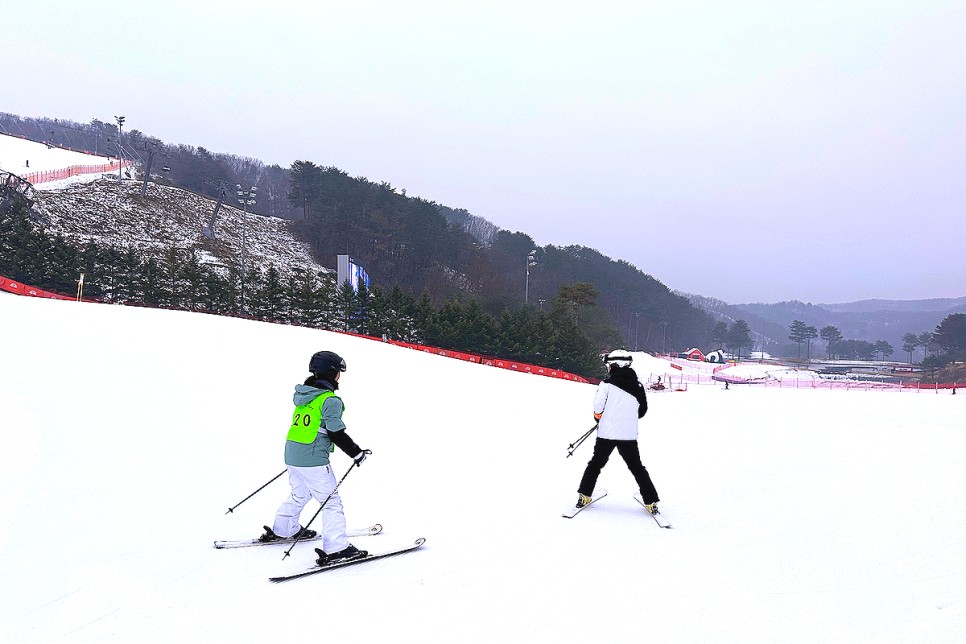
[[258, 351, 371, 563]]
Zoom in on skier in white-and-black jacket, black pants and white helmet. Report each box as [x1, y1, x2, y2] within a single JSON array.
[[577, 349, 660, 514]]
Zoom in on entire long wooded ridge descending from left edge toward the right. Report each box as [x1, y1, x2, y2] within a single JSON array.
[[0, 114, 711, 362]]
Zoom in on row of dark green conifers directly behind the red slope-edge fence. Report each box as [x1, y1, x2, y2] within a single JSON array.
[[0, 202, 601, 377]]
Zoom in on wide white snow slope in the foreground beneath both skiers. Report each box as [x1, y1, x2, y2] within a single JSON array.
[[0, 296, 966, 644]]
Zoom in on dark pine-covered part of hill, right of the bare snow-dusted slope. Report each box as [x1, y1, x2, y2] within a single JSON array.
[[291, 161, 710, 350]]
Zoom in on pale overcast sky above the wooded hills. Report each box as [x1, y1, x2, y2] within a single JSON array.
[[0, 0, 966, 303]]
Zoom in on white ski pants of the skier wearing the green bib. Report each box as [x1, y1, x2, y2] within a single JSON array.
[[272, 465, 349, 553]]
